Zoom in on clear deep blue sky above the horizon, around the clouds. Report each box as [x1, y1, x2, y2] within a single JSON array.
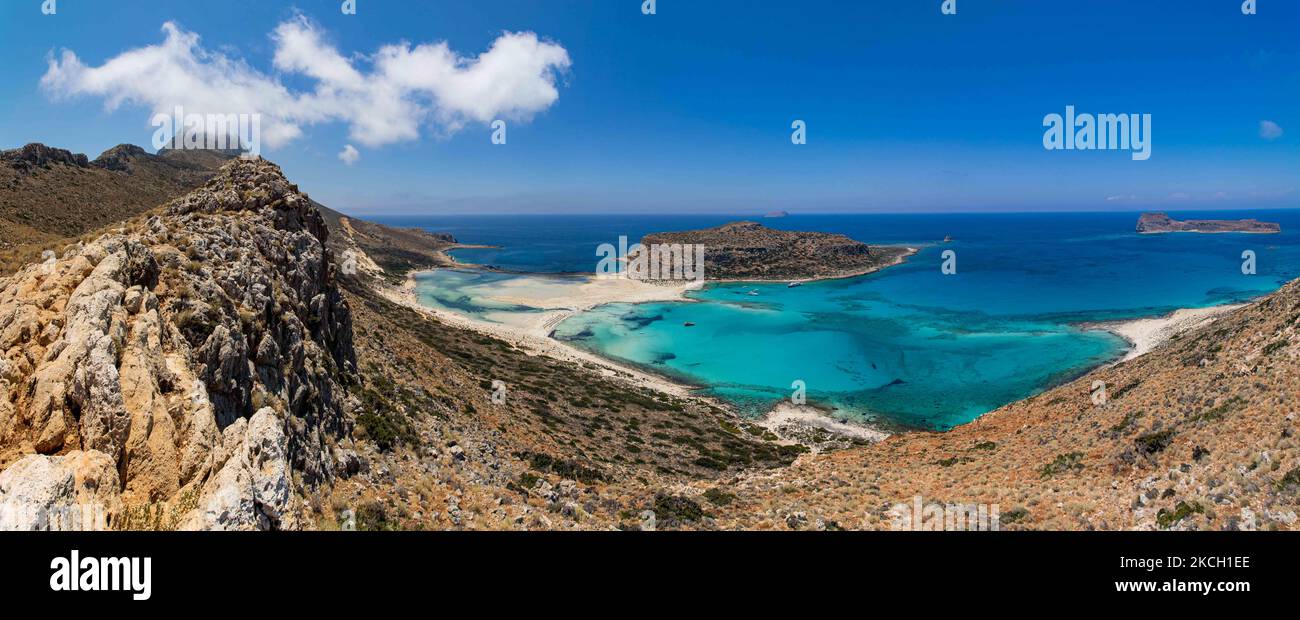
[[0, 0, 1300, 214]]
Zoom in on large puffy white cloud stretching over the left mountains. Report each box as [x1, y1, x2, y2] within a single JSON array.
[[40, 17, 571, 152]]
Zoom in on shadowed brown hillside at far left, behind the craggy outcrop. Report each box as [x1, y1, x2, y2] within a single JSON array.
[[0, 144, 233, 273]]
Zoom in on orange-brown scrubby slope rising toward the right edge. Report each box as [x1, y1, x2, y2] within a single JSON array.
[[697, 281, 1300, 529]]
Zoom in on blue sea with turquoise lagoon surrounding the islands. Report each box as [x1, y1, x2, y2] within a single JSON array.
[[380, 211, 1300, 429]]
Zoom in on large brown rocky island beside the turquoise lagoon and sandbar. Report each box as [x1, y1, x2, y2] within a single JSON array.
[[641, 221, 915, 281]]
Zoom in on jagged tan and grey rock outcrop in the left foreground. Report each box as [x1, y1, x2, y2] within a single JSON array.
[[0, 160, 355, 529]]
